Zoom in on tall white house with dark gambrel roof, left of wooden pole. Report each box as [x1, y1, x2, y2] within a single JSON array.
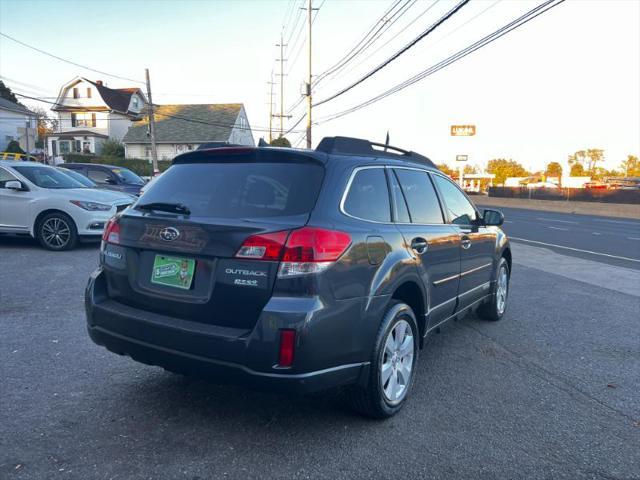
[[47, 77, 147, 156]]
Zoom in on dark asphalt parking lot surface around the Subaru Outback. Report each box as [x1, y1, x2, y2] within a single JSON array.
[[0, 230, 640, 480]]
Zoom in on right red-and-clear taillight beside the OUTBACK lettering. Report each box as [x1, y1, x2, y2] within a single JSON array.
[[236, 227, 351, 278]]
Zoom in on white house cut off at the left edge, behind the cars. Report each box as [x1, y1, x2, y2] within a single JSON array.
[[0, 98, 37, 152]]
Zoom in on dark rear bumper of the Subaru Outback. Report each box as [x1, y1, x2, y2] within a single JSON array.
[[85, 270, 368, 394]]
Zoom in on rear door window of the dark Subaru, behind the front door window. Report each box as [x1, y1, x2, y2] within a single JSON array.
[[394, 169, 444, 223]]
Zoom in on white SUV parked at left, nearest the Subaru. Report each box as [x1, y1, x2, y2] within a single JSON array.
[[0, 161, 134, 250]]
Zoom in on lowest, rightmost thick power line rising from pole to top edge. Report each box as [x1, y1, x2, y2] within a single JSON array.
[[316, 0, 565, 124]]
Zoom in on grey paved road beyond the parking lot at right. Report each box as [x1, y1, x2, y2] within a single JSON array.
[[480, 207, 640, 269]]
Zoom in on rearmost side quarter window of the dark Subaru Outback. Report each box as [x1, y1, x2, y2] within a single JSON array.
[[344, 168, 391, 222]]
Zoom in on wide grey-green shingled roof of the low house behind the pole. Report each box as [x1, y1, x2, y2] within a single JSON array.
[[122, 103, 243, 143]]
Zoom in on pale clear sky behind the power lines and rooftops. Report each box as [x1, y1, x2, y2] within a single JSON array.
[[0, 0, 640, 171]]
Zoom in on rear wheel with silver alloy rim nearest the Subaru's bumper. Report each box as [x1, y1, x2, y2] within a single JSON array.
[[347, 301, 419, 418]]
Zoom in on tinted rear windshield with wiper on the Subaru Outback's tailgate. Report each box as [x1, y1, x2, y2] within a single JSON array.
[[140, 162, 324, 219]]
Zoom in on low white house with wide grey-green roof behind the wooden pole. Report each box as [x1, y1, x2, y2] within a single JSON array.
[[122, 103, 255, 160]]
